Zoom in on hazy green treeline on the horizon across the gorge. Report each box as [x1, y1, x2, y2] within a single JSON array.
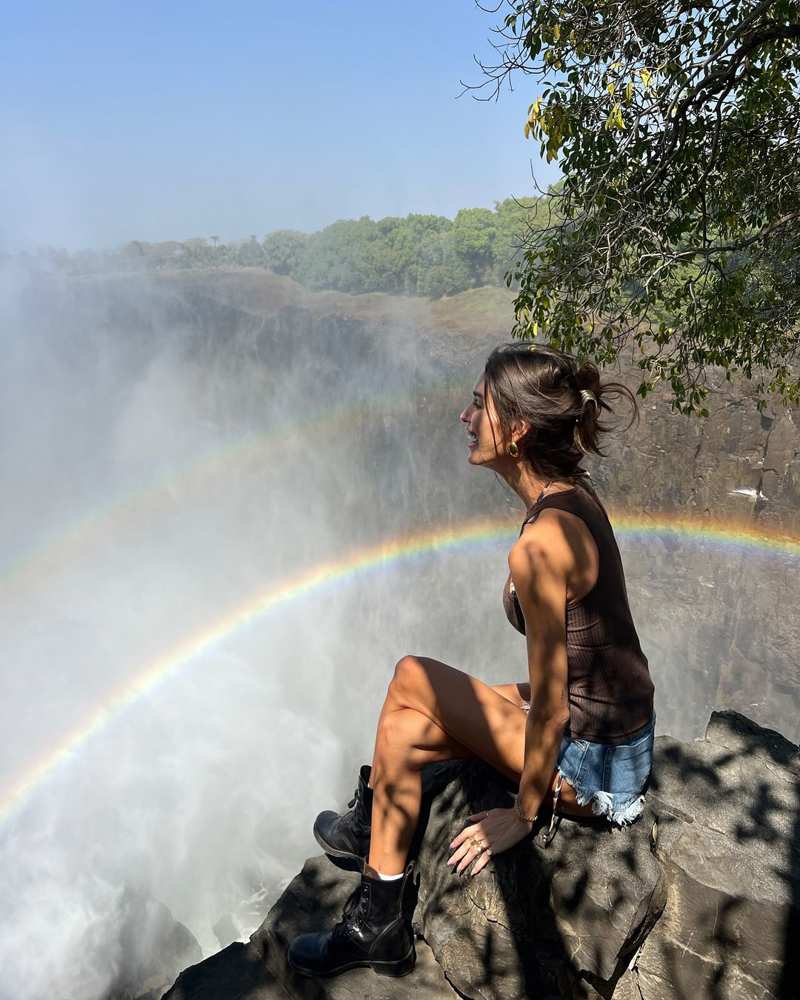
[[15, 198, 547, 298]]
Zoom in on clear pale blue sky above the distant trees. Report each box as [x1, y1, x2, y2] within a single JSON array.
[[0, 0, 556, 248]]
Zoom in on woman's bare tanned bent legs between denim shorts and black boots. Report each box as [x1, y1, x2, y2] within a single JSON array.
[[369, 656, 591, 875]]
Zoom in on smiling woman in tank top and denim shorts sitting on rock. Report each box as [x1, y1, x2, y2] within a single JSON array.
[[289, 344, 655, 976]]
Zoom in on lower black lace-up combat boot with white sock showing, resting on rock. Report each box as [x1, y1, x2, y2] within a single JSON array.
[[289, 862, 417, 976]]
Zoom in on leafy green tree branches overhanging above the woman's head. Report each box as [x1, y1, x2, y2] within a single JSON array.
[[478, 0, 800, 413]]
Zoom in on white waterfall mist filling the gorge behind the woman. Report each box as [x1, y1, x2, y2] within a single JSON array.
[[0, 268, 797, 1000]]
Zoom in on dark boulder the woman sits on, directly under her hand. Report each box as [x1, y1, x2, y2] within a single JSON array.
[[406, 763, 664, 998]]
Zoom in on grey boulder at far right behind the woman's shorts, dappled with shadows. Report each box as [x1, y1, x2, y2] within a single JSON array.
[[632, 712, 800, 1000]]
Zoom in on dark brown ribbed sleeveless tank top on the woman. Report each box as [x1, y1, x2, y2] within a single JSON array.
[[503, 486, 653, 744]]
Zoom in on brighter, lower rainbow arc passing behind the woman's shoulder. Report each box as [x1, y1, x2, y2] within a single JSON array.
[[0, 512, 800, 822]]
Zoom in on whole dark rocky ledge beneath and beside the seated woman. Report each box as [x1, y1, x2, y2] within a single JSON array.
[[165, 712, 800, 1000]]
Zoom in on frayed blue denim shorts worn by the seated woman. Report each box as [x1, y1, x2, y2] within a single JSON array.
[[557, 714, 656, 826]]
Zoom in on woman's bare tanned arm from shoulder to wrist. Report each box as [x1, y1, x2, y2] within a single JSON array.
[[508, 511, 574, 816]]
